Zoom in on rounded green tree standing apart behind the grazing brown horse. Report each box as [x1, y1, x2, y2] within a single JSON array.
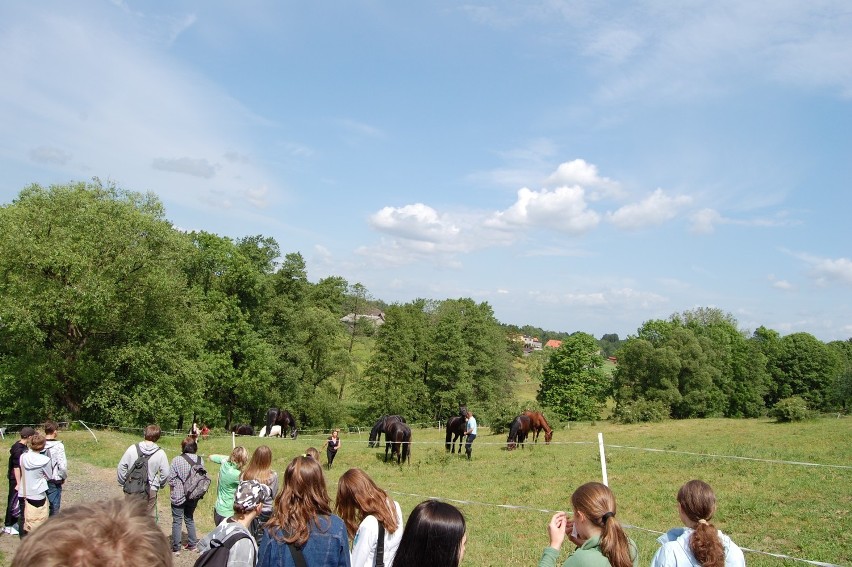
[[537, 333, 612, 420]]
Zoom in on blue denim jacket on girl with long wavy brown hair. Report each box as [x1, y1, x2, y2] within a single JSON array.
[[257, 515, 350, 567]]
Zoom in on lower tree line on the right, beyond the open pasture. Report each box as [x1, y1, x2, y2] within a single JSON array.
[[538, 308, 852, 422]]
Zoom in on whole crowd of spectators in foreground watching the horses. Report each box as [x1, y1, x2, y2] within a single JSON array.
[[4, 422, 745, 567]]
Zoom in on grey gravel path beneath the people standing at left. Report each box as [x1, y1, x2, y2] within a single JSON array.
[[0, 462, 205, 567]]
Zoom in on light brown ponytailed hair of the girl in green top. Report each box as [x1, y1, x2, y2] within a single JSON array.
[[571, 482, 633, 567]]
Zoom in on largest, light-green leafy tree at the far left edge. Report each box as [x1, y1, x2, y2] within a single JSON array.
[[0, 179, 201, 424]]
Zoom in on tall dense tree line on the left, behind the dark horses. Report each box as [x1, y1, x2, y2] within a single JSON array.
[[0, 179, 513, 428]]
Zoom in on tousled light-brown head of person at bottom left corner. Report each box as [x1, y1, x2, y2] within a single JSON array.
[[12, 498, 172, 567]]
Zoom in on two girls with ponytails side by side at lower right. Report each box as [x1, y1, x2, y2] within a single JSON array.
[[538, 480, 745, 567]]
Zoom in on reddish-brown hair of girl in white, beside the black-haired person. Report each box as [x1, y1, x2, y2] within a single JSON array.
[[334, 469, 399, 537]]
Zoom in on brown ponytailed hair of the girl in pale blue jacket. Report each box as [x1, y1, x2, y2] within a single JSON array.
[[677, 480, 725, 567]]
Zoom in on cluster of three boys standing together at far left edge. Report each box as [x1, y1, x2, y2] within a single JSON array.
[[3, 421, 68, 538]]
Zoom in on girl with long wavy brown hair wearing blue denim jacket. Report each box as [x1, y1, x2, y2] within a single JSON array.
[[257, 456, 350, 567]]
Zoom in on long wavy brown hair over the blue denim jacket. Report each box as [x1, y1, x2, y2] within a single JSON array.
[[266, 457, 331, 545]]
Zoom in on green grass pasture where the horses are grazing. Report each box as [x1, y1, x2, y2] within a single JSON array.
[[2, 418, 852, 566]]
